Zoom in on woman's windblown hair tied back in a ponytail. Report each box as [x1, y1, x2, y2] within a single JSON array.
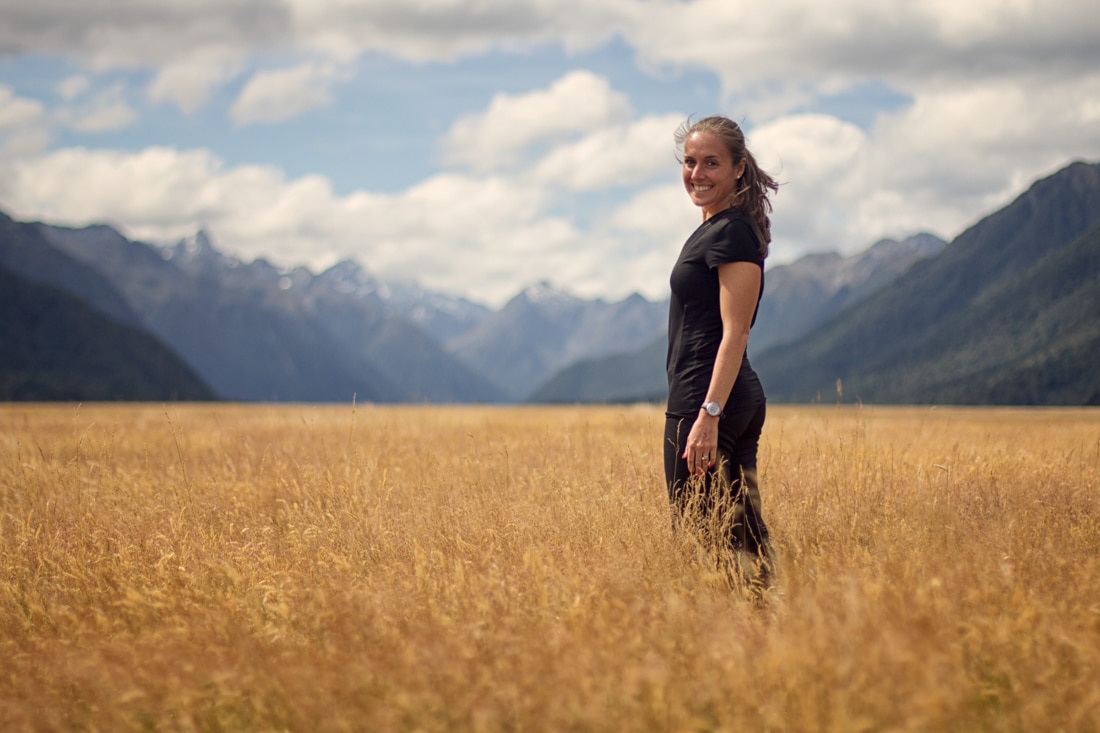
[[675, 114, 779, 260]]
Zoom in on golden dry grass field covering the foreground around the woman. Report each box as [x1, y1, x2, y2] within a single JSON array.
[[0, 404, 1100, 732]]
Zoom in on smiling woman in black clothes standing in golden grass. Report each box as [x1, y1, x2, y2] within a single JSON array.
[[664, 117, 779, 586]]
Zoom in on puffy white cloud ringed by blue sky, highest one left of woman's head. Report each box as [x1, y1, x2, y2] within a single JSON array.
[[435, 70, 630, 171]]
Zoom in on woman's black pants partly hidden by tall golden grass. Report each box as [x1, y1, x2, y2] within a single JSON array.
[[664, 391, 770, 559]]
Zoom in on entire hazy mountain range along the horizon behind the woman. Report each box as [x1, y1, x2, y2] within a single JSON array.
[[0, 157, 1100, 404]]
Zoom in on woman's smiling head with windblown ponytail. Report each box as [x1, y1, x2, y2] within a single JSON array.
[[675, 116, 779, 256]]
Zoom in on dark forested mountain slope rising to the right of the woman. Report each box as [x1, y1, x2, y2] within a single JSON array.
[[756, 157, 1100, 404]]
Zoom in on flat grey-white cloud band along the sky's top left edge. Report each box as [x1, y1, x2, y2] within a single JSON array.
[[0, 0, 624, 68]]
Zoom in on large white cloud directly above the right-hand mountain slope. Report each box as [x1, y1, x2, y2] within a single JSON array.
[[831, 73, 1100, 245]]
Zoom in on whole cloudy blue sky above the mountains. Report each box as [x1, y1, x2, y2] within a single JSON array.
[[0, 0, 1100, 307]]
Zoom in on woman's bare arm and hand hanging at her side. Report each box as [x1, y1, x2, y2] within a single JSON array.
[[683, 262, 760, 474]]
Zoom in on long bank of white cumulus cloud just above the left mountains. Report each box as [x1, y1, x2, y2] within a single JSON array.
[[0, 147, 606, 303]]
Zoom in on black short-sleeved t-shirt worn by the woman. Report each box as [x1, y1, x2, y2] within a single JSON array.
[[667, 209, 763, 417]]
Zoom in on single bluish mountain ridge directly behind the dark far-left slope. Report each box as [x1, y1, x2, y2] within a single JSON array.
[[40, 225, 405, 402]]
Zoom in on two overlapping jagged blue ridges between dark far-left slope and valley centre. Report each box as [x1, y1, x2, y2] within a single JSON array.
[[31, 225, 495, 402]]
